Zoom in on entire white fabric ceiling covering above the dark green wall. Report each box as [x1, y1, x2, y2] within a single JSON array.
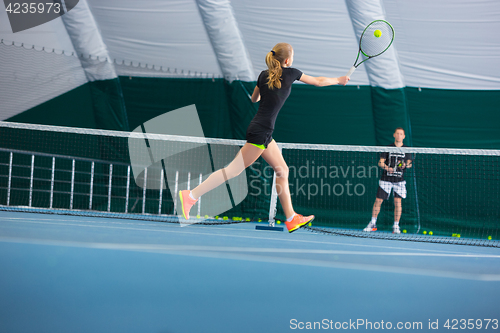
[[0, 0, 500, 107]]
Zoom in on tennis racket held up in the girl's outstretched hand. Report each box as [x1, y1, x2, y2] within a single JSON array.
[[346, 20, 394, 77]]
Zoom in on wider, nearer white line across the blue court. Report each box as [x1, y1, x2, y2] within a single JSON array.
[[0, 238, 500, 282]]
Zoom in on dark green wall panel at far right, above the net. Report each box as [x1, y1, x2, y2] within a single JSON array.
[[405, 87, 500, 149]]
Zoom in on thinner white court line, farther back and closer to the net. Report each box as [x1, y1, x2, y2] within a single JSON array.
[[2, 217, 492, 254]]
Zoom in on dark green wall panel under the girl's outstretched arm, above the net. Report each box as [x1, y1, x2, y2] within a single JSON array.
[[273, 84, 375, 145]]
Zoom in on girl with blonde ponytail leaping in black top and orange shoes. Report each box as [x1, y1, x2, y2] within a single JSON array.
[[179, 43, 349, 232]]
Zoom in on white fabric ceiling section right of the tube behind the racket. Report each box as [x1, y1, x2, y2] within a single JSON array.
[[383, 0, 500, 90]]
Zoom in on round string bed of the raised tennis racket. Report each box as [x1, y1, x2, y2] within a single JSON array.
[[360, 21, 394, 57]]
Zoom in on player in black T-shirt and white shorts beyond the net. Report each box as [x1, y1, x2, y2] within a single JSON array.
[[364, 127, 413, 234]]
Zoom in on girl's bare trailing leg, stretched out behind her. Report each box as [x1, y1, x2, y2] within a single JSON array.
[[191, 143, 264, 199]]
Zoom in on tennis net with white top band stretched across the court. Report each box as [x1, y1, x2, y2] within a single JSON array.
[[0, 122, 500, 246]]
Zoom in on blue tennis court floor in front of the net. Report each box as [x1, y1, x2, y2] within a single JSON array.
[[0, 212, 500, 333]]
